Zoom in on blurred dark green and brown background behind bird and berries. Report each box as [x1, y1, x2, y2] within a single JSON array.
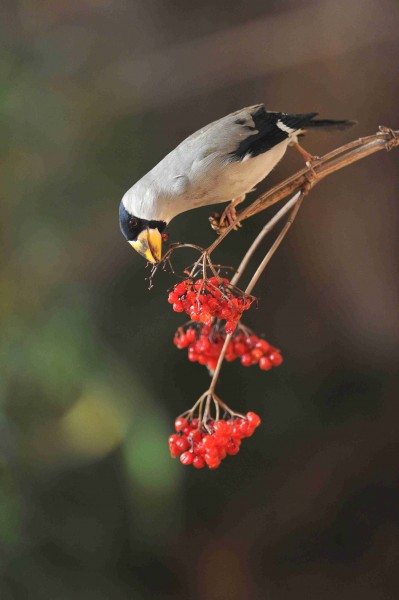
[[0, 0, 399, 600]]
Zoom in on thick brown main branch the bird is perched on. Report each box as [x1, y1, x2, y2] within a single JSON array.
[[208, 126, 399, 247]]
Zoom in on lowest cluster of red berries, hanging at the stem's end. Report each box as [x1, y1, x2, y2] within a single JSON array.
[[169, 412, 261, 469]]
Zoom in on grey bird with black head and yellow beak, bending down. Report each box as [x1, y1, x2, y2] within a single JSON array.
[[119, 104, 356, 263]]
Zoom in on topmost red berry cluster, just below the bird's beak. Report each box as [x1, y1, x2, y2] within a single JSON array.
[[168, 277, 253, 333]]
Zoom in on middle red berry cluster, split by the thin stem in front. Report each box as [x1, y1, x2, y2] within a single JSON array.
[[173, 324, 283, 371]]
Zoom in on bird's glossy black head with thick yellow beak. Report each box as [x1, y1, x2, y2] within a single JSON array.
[[119, 200, 167, 263]]
